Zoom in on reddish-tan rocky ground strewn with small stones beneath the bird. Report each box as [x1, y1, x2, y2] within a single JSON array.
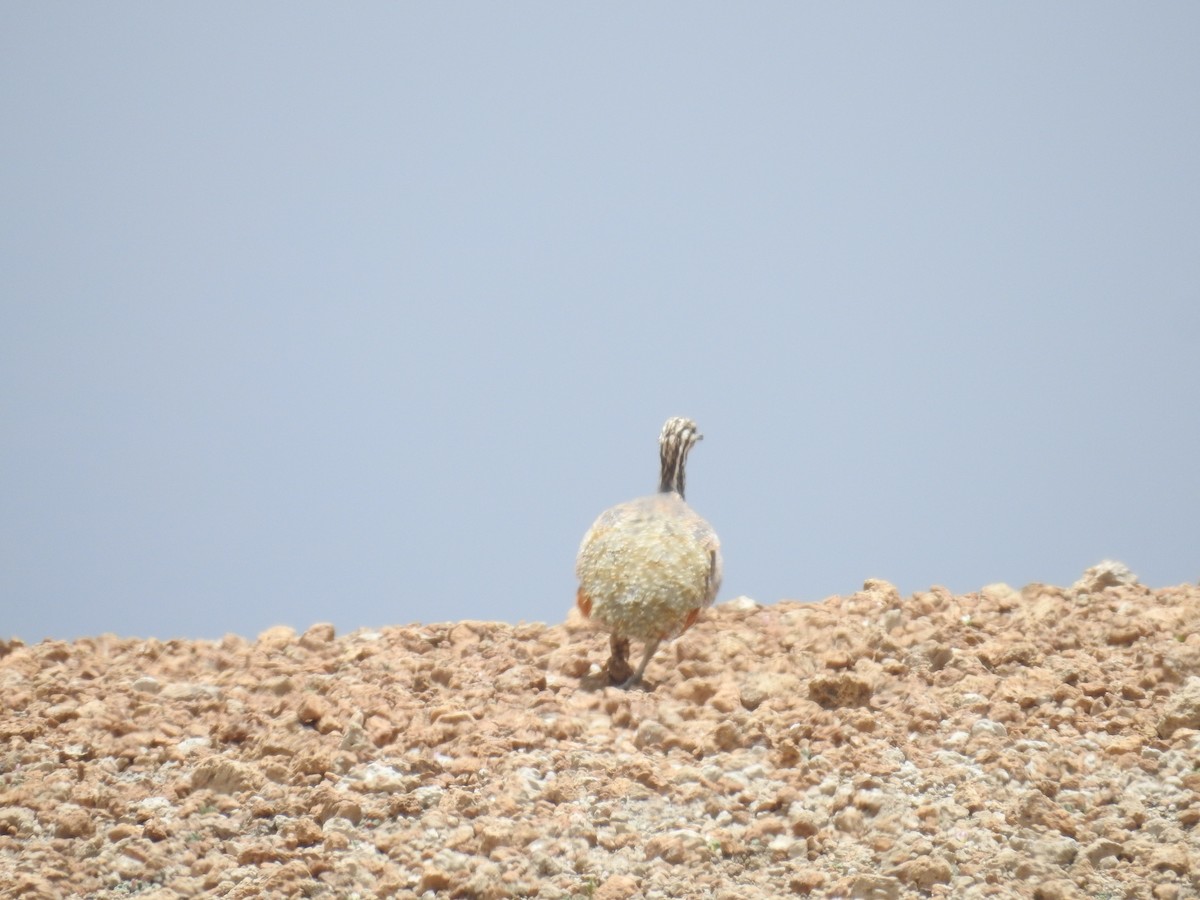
[[0, 564, 1200, 900]]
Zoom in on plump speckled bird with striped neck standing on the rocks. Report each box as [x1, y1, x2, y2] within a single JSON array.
[[575, 416, 721, 688]]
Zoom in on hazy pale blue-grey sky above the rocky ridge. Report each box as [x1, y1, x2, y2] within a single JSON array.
[[0, 2, 1200, 641]]
